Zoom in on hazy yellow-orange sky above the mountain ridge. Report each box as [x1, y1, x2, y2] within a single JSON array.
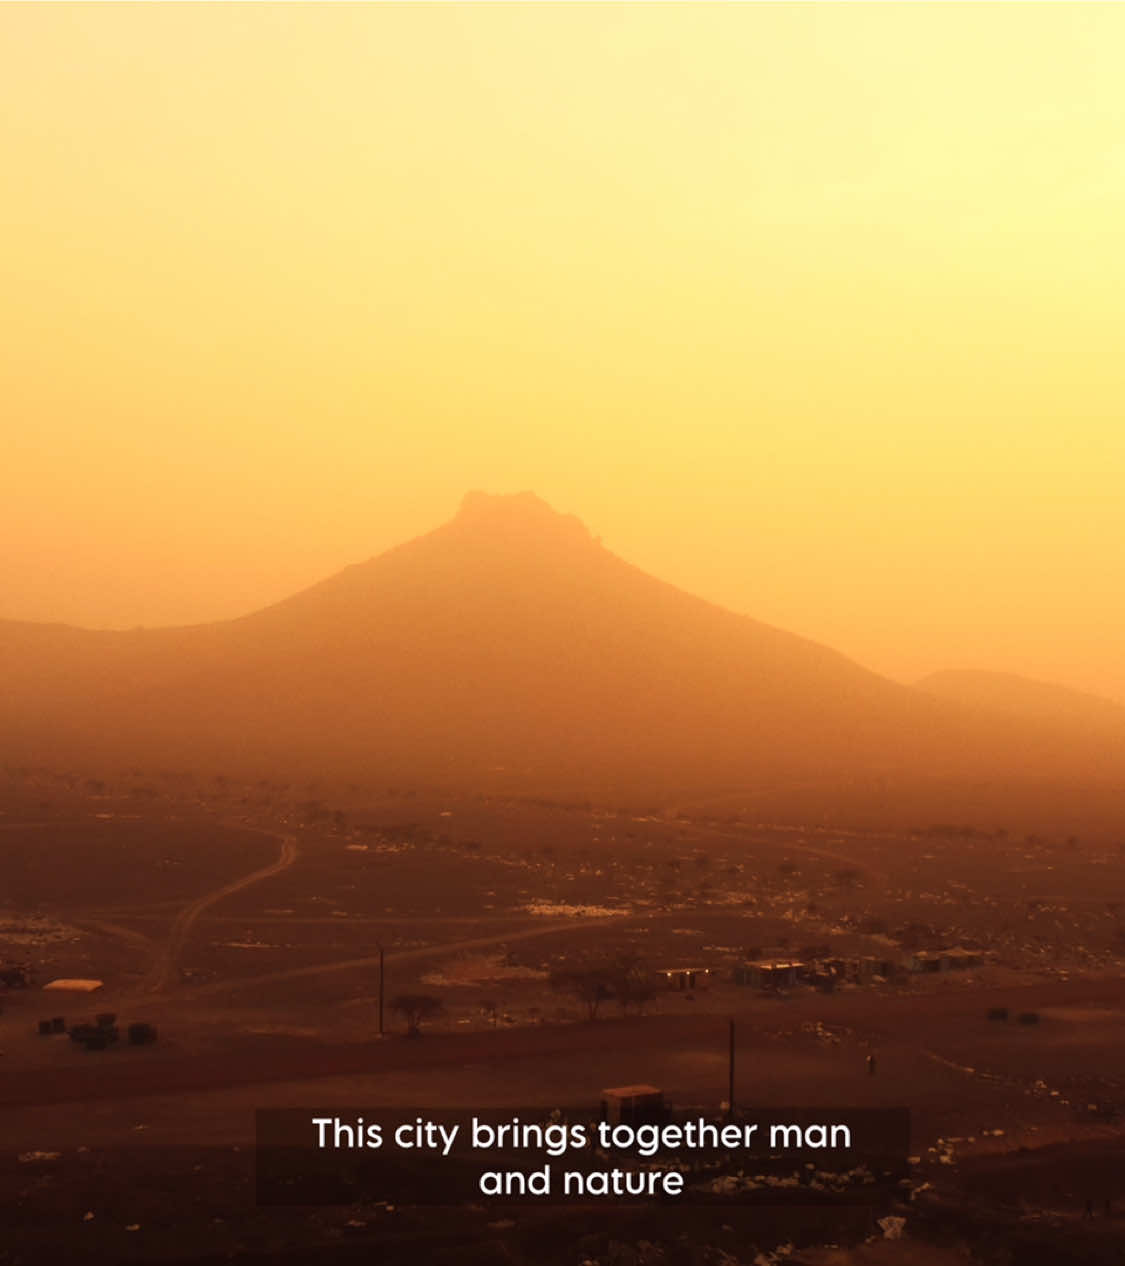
[[0, 4, 1125, 700]]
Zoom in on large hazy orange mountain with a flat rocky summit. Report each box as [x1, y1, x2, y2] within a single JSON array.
[[0, 492, 1125, 804]]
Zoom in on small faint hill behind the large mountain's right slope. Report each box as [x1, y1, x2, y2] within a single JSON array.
[[917, 670, 1125, 734]]
